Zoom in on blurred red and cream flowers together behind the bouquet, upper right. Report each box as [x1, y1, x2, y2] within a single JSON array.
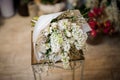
[[86, 0, 119, 37]]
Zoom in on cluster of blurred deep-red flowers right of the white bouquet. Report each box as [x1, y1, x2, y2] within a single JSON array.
[[88, 8, 114, 37]]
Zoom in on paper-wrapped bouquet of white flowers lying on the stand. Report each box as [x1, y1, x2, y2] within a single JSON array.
[[33, 10, 90, 68]]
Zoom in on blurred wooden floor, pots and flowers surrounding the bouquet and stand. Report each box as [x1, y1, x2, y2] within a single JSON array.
[[0, 0, 120, 80]]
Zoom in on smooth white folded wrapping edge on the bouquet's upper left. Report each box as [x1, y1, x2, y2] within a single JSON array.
[[33, 12, 62, 43]]
